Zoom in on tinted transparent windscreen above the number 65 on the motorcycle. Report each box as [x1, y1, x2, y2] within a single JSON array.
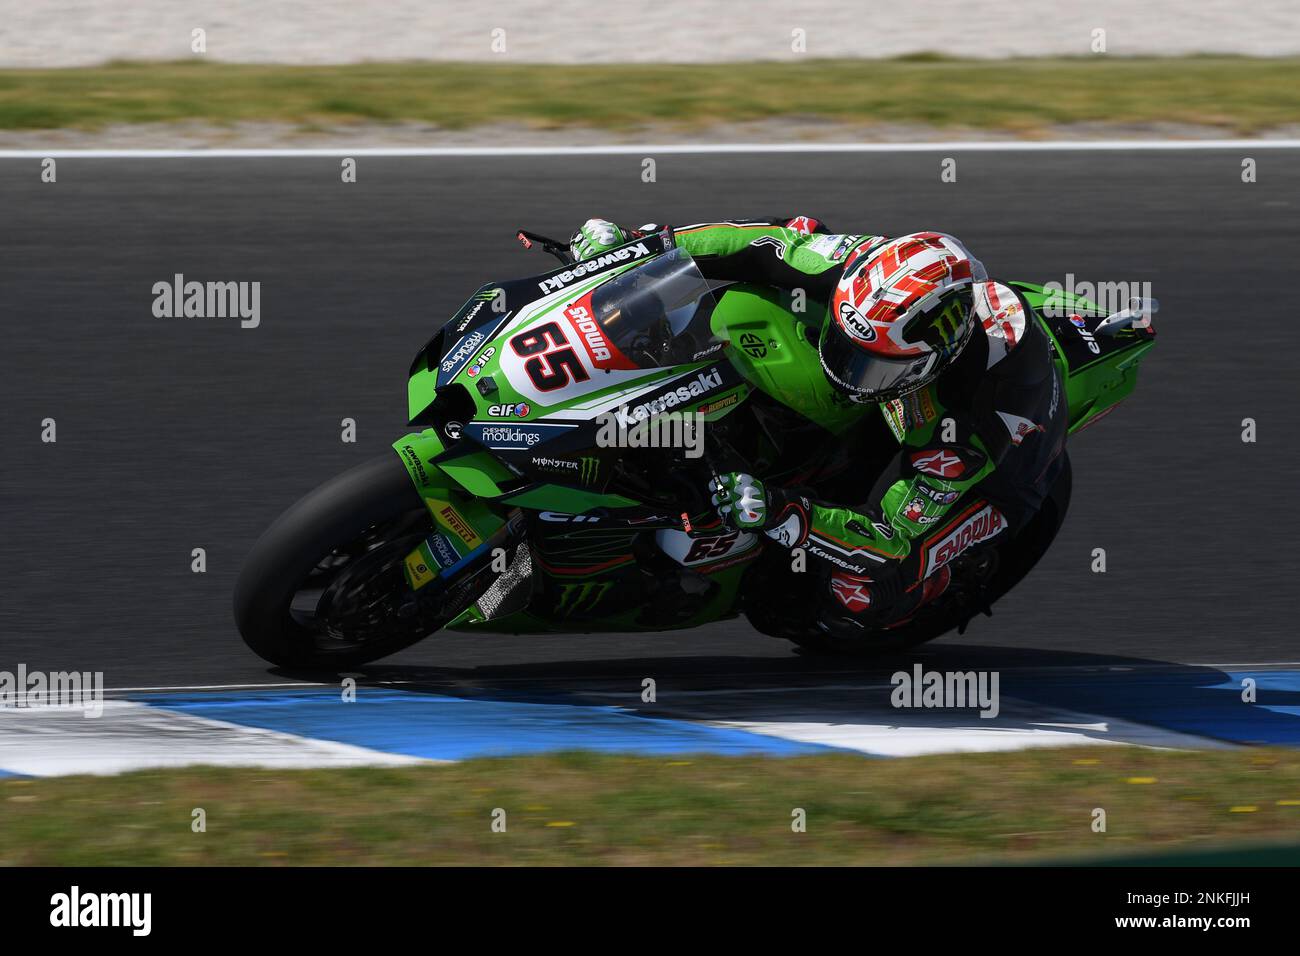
[[592, 248, 719, 368]]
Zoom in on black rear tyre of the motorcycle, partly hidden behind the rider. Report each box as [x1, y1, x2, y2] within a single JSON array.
[[790, 458, 1073, 657]]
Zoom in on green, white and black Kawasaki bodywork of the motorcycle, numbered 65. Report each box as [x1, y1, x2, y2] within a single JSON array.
[[394, 237, 1154, 633]]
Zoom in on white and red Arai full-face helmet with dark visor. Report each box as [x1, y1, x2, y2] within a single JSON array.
[[820, 233, 988, 402]]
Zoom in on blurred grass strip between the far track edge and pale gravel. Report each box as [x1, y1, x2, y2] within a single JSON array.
[[0, 57, 1300, 135]]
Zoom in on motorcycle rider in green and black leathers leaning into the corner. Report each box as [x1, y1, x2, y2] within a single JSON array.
[[569, 216, 1066, 637]]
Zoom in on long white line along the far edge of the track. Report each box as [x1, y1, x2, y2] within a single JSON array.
[[0, 139, 1300, 159]]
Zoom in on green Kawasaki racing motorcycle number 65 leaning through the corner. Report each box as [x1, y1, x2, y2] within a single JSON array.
[[234, 232, 1156, 669]]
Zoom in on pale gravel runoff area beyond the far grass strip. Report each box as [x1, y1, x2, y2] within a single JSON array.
[[0, 0, 1300, 68]]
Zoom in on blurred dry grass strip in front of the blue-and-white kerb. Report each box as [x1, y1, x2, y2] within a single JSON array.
[[0, 747, 1300, 865]]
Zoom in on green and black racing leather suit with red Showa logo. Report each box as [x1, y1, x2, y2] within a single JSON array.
[[592, 216, 1067, 630]]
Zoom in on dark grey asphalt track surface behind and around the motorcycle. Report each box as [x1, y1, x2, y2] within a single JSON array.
[[0, 150, 1300, 688]]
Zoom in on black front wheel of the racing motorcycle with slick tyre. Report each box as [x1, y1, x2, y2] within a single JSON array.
[[234, 454, 490, 670]]
